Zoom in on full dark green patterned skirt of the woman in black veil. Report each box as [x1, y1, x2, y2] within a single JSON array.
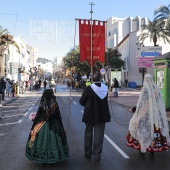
[[26, 122, 69, 163]]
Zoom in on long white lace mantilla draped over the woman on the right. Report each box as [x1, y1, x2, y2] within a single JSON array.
[[129, 75, 169, 152]]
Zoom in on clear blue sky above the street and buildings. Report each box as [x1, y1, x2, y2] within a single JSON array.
[[0, 0, 170, 62]]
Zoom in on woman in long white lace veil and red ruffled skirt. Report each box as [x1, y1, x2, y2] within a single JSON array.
[[126, 74, 169, 155]]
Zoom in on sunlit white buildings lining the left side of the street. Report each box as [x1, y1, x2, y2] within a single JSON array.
[[6, 36, 37, 81]]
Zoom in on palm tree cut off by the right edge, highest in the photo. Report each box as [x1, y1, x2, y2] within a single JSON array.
[[154, 4, 170, 30]]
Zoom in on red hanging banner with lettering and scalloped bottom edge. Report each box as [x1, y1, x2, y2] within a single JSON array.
[[79, 19, 105, 65]]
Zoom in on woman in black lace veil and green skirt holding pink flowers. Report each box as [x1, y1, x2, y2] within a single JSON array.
[[26, 89, 69, 163]]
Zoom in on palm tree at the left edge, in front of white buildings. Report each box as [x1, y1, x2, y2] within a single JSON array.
[[0, 26, 20, 76]]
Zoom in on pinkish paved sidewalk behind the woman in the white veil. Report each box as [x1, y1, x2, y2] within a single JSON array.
[[111, 88, 170, 121]]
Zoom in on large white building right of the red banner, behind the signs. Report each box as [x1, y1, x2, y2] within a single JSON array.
[[106, 16, 170, 86]]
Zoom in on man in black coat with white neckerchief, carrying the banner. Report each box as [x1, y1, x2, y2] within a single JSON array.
[[79, 73, 110, 161]]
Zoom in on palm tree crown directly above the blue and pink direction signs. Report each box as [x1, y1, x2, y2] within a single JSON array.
[[137, 19, 170, 46]]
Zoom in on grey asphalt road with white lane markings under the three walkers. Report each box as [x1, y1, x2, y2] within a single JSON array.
[[0, 85, 170, 170]]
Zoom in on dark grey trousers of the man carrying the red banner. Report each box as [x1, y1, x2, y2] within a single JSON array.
[[84, 123, 105, 159]]
